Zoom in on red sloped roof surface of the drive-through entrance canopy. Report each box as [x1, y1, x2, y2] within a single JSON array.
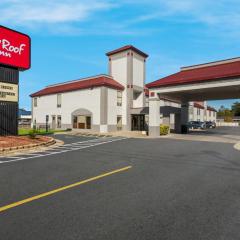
[[146, 59, 240, 88]]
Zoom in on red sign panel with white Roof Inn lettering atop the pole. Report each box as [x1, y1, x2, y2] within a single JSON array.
[[0, 26, 31, 70]]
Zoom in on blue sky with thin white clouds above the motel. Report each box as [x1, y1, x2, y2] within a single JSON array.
[[0, 0, 240, 109]]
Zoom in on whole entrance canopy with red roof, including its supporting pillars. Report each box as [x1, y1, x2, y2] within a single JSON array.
[[146, 55, 240, 136]]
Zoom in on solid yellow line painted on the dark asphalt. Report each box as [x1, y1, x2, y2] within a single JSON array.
[[0, 166, 132, 212]]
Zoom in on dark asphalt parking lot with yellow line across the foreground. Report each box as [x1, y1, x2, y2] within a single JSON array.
[[0, 132, 240, 240]]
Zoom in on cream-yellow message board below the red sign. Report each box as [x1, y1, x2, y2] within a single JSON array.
[[0, 82, 18, 102]]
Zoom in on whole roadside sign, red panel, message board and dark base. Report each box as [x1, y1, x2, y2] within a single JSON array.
[[0, 25, 31, 136]]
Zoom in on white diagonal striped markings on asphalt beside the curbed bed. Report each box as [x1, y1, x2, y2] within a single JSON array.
[[0, 138, 126, 164]]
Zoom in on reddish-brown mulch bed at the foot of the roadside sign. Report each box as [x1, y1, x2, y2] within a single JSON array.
[[0, 136, 50, 148]]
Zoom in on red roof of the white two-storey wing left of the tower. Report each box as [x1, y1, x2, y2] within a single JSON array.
[[30, 75, 124, 97]]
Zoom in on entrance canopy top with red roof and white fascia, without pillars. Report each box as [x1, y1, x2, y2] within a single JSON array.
[[147, 58, 240, 102]]
